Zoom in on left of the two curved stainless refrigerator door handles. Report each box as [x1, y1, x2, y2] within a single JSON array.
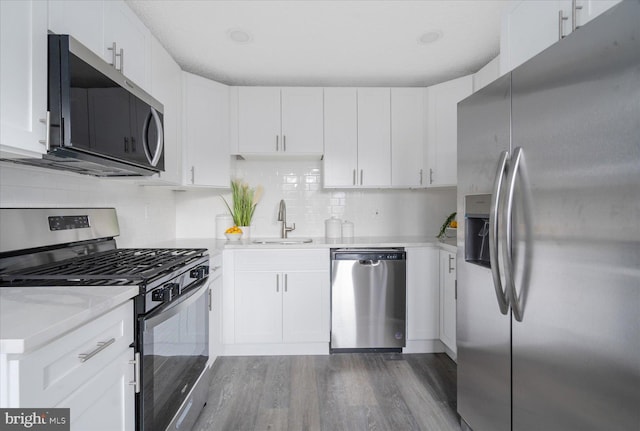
[[489, 150, 509, 314]]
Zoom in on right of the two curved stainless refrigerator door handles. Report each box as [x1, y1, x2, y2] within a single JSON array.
[[504, 147, 531, 322]]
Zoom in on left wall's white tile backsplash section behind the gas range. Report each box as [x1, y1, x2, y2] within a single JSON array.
[[0, 163, 176, 247]]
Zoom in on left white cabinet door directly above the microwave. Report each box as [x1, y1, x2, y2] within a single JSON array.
[[48, 0, 105, 56]]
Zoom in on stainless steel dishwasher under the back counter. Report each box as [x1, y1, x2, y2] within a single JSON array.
[[330, 248, 406, 352]]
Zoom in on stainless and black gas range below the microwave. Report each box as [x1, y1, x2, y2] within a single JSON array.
[[0, 208, 211, 430]]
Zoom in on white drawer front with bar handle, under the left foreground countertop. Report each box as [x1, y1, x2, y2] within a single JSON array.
[[12, 301, 133, 407]]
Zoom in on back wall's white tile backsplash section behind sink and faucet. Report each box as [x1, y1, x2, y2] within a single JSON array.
[[176, 160, 456, 238]]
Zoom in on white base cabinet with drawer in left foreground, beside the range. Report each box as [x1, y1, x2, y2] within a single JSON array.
[[2, 301, 137, 431]]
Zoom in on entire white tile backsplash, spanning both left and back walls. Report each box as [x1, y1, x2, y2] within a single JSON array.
[[0, 160, 456, 247]]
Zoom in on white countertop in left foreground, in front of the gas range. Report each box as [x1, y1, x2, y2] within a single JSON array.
[[0, 286, 139, 354]]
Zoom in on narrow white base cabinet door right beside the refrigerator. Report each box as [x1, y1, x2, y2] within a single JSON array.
[[440, 250, 456, 354]]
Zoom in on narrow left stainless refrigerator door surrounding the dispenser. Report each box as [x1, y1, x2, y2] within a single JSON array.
[[457, 75, 511, 431]]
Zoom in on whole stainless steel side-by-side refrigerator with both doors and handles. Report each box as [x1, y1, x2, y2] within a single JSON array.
[[457, 0, 640, 431]]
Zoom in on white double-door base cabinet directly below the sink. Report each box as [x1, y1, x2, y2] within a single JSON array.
[[223, 249, 330, 354]]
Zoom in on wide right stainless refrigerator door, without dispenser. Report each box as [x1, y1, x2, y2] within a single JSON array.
[[510, 0, 640, 431]]
